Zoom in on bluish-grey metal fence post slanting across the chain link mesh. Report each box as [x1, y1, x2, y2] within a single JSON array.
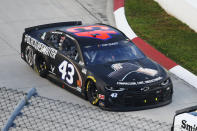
[[2, 88, 36, 131]]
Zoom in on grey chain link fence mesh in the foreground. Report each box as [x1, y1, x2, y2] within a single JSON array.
[[0, 87, 171, 131]]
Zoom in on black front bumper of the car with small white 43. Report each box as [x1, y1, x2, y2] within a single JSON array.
[[99, 84, 173, 111]]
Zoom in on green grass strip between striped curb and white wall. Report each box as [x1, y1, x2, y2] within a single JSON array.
[[125, 0, 197, 75]]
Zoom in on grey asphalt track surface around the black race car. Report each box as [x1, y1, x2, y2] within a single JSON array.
[[0, 0, 197, 123]]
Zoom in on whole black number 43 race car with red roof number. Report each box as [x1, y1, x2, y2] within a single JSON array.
[[21, 21, 173, 110]]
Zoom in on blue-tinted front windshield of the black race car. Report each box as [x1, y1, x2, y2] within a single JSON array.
[[83, 40, 145, 65]]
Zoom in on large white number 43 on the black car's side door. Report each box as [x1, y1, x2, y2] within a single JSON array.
[[59, 61, 75, 84]]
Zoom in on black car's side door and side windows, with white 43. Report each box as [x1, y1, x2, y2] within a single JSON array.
[[42, 31, 83, 92]]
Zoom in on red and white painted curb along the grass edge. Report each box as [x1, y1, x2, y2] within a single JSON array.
[[114, 0, 197, 88]]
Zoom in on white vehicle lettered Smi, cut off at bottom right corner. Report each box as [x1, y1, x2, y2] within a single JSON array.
[[171, 106, 197, 131]]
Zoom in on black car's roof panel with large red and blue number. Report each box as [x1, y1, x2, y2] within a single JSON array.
[[57, 24, 127, 46]]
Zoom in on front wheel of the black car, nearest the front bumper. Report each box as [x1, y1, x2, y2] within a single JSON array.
[[86, 80, 99, 105]]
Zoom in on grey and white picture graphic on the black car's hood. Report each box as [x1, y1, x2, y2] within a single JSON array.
[[108, 62, 158, 81]]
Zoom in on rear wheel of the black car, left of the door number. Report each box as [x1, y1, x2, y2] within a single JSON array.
[[34, 54, 47, 77]]
